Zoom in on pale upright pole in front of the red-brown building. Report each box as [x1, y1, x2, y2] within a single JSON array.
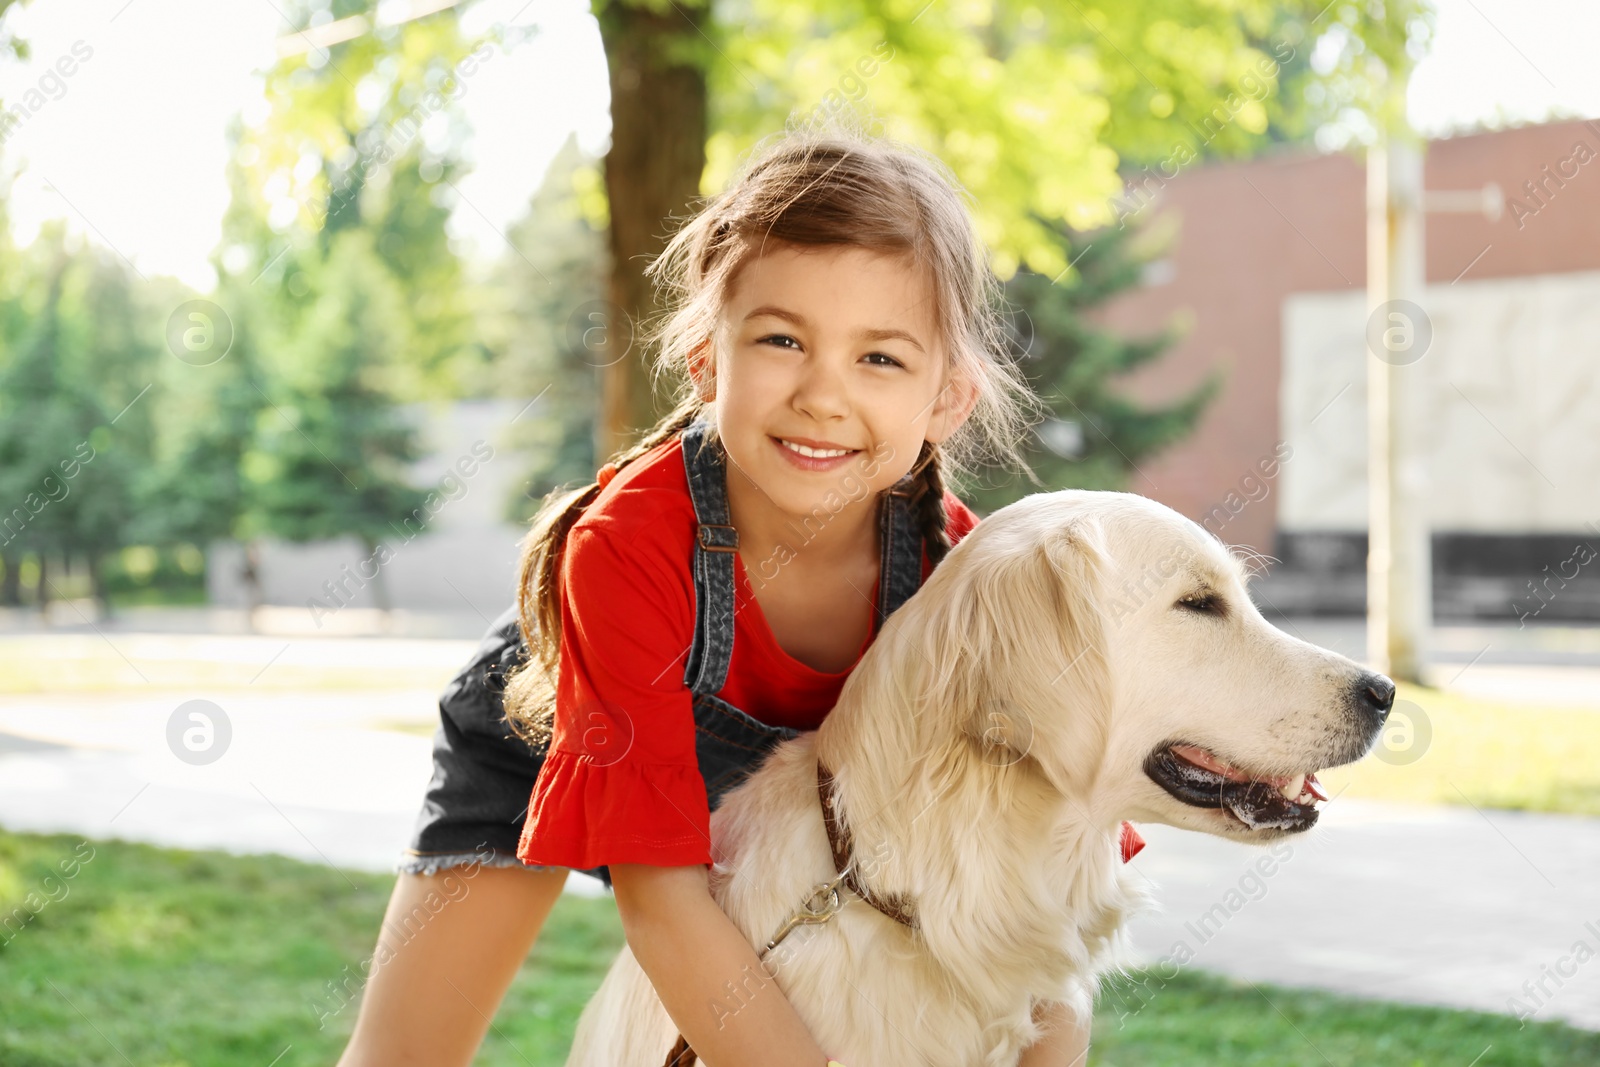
[[1366, 72, 1432, 681]]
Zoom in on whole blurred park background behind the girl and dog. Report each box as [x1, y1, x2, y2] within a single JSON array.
[[0, 0, 1600, 1067]]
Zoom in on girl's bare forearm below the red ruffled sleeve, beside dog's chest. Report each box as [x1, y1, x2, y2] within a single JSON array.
[[610, 864, 827, 1067]]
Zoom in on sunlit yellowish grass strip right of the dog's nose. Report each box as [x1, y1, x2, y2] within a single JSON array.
[[1317, 685, 1600, 816]]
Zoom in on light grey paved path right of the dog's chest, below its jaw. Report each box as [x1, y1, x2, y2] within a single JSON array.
[[1123, 797, 1600, 1029]]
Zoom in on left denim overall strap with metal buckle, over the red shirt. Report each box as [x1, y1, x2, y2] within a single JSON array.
[[682, 419, 739, 696]]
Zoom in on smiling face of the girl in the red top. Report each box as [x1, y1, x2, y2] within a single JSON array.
[[701, 243, 976, 517]]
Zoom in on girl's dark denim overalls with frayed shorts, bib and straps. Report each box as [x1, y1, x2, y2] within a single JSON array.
[[398, 421, 922, 885]]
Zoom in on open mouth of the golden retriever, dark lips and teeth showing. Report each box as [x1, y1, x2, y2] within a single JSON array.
[[1144, 742, 1328, 833]]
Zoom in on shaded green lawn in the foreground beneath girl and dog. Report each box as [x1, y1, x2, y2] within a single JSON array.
[[0, 832, 1600, 1067]]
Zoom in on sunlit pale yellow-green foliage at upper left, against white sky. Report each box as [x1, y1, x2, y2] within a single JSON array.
[[222, 0, 498, 400]]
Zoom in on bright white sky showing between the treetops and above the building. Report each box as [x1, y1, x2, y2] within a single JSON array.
[[0, 0, 1600, 291]]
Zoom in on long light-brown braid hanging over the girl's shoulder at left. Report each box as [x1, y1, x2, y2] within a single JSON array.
[[506, 397, 706, 745]]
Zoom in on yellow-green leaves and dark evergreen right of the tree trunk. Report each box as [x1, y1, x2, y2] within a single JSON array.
[[656, 0, 1427, 509]]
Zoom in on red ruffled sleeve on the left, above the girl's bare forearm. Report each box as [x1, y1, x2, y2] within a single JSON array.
[[517, 523, 710, 869]]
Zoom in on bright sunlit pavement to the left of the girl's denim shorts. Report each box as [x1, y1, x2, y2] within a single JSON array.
[[0, 687, 603, 894]]
